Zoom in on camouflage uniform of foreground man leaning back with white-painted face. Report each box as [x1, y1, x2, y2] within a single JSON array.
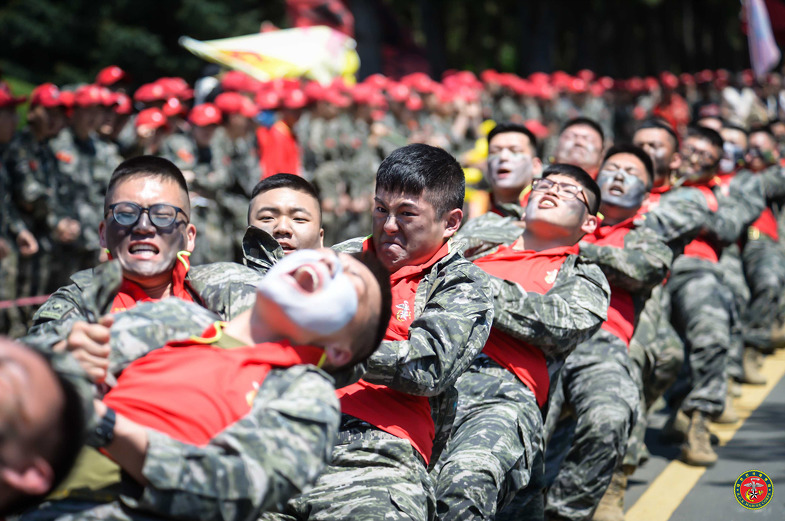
[[22, 286, 339, 521]]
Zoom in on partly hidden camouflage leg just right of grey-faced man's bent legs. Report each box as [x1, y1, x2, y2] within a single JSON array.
[[624, 286, 684, 467]]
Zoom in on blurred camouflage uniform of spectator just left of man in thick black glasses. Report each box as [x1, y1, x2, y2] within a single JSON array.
[[49, 128, 122, 286]]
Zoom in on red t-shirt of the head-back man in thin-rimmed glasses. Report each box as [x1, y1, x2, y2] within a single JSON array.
[[474, 245, 579, 407]]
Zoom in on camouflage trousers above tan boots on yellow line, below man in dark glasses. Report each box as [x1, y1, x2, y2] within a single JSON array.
[[666, 269, 736, 417]]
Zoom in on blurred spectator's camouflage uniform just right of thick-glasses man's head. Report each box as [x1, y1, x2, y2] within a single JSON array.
[[161, 133, 233, 265]]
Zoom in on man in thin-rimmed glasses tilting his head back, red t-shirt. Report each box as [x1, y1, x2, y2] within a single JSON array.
[[433, 164, 610, 519]]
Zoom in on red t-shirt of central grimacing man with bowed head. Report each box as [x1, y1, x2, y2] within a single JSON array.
[[337, 239, 449, 463]]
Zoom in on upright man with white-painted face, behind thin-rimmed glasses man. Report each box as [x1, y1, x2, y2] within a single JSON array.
[[459, 123, 542, 254]]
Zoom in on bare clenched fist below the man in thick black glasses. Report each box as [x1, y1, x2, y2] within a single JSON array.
[[54, 315, 114, 384]]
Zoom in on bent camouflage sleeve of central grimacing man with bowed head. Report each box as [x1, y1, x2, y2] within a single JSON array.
[[363, 252, 493, 396]]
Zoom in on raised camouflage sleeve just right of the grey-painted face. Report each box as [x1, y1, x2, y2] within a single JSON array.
[[636, 187, 711, 247]]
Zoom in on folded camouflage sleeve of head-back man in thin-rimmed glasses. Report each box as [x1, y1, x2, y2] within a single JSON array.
[[492, 255, 611, 360]]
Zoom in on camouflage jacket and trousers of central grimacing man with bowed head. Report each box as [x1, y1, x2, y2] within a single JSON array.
[[265, 239, 493, 520]]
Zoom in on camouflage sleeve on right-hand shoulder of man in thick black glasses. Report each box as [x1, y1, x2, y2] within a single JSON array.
[[188, 262, 263, 320]]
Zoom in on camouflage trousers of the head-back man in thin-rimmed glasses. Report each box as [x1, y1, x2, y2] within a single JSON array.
[[432, 354, 544, 520]]
